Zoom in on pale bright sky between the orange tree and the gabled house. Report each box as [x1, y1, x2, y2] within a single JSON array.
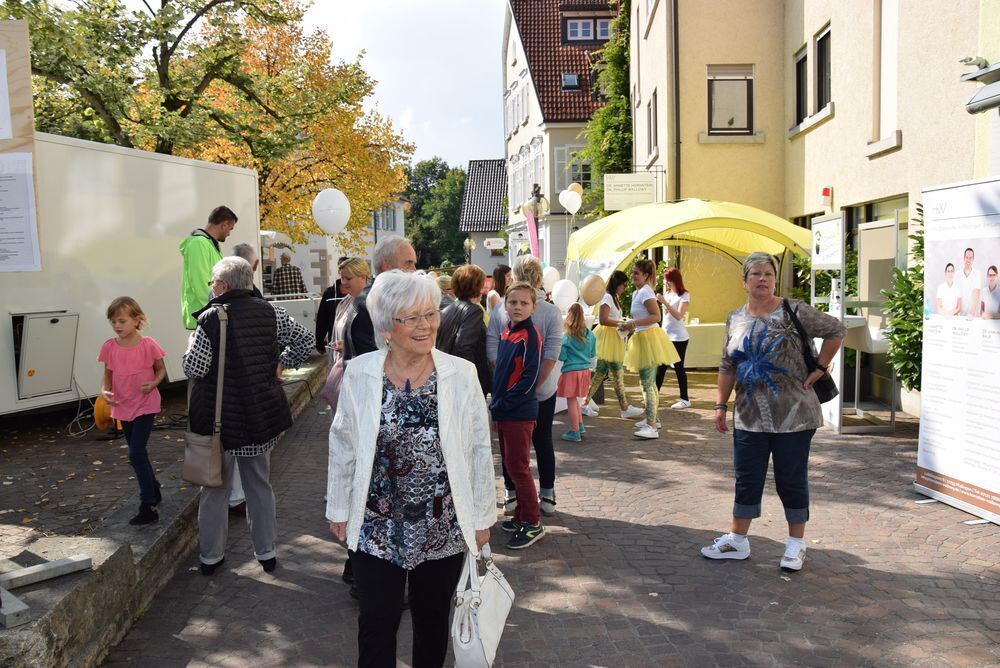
[[306, 0, 506, 167]]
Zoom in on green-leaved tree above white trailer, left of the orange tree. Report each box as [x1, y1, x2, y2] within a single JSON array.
[[0, 0, 303, 154]]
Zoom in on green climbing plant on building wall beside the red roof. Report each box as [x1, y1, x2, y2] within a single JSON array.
[[576, 0, 632, 216]]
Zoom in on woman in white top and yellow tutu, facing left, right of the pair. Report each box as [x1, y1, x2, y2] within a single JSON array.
[[621, 260, 680, 438]]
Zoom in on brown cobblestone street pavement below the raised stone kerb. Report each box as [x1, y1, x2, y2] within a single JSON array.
[[108, 373, 1000, 668]]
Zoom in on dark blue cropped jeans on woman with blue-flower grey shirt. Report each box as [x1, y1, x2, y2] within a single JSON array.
[[733, 429, 816, 524]]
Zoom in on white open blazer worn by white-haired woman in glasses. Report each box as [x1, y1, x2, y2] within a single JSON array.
[[326, 348, 497, 553]]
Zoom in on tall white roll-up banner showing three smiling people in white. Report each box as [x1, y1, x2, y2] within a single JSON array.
[[915, 179, 1000, 524]]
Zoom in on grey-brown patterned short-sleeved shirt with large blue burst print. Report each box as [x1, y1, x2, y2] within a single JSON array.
[[719, 299, 846, 434]]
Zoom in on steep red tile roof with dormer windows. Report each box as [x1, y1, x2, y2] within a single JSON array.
[[510, 0, 611, 122]]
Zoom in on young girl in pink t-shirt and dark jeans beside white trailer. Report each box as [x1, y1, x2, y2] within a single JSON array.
[[97, 297, 167, 525]]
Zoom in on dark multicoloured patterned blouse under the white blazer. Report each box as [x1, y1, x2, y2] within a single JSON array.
[[358, 371, 465, 570]]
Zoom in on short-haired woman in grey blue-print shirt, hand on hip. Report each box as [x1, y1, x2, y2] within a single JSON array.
[[701, 253, 845, 571]]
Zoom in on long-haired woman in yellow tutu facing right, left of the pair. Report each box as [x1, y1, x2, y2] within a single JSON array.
[[583, 271, 642, 419]]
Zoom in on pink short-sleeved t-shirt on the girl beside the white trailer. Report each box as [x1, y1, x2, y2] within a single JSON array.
[[97, 336, 165, 421]]
